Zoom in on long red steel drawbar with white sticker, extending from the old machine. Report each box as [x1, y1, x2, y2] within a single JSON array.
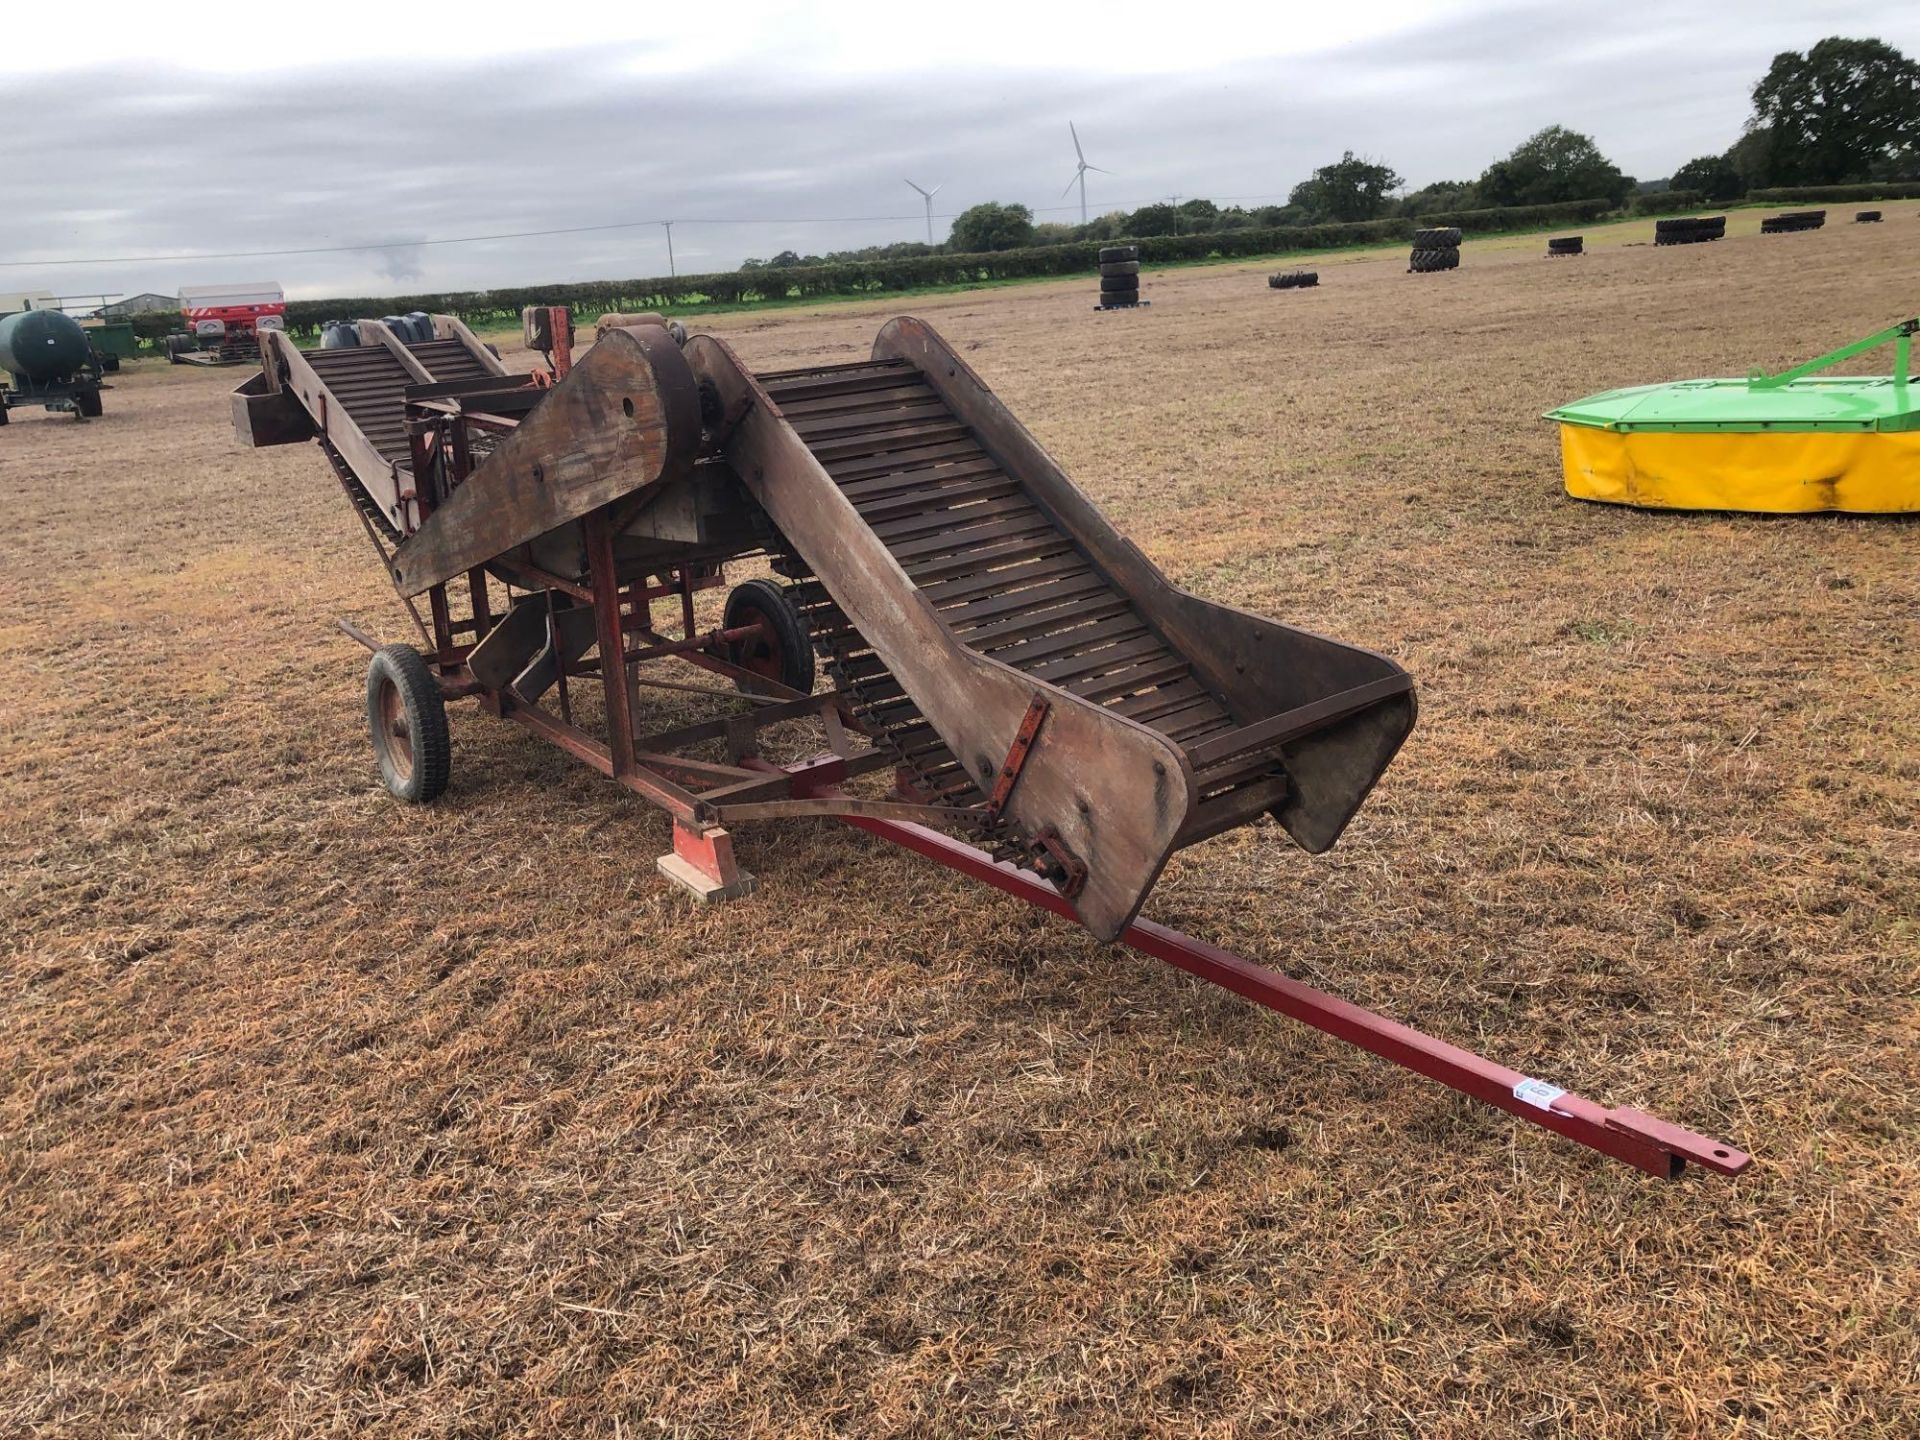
[[745, 756, 1753, 1179]]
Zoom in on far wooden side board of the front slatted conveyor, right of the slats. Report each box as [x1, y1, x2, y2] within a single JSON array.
[[874, 317, 1415, 852]]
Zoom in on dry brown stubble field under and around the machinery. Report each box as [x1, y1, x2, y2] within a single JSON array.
[[11, 216, 1920, 1440]]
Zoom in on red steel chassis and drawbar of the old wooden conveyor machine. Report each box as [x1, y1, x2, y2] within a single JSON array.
[[342, 340, 1751, 1179]]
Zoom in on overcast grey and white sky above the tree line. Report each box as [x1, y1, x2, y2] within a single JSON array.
[[0, 0, 1920, 298]]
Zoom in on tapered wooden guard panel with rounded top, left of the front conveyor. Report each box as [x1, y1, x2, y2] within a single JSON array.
[[394, 326, 701, 595]]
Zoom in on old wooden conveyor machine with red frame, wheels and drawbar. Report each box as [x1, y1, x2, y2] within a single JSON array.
[[234, 309, 1747, 1177]]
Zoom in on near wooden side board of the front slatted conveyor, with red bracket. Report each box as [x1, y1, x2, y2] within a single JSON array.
[[691, 336, 1196, 941]]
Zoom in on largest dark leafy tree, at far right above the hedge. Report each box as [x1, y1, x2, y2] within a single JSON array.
[[1747, 35, 1920, 184]]
